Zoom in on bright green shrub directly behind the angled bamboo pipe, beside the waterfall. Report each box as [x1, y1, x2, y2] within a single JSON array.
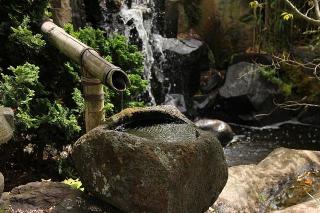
[[65, 24, 148, 115]]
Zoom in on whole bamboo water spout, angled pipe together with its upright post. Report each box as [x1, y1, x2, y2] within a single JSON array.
[[41, 21, 130, 132]]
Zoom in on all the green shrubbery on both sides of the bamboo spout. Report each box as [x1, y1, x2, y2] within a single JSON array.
[[0, 0, 147, 178]]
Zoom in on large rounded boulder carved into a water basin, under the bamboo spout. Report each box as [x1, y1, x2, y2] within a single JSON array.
[[72, 106, 228, 213]]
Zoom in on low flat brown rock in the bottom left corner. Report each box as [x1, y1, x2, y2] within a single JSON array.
[[0, 181, 120, 213]]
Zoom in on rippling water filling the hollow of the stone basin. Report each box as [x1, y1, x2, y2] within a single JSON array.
[[122, 123, 199, 143]]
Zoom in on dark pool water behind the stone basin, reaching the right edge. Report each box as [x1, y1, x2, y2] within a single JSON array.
[[224, 121, 320, 166]]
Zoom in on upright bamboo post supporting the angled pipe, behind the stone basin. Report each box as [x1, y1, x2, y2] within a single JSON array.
[[82, 70, 105, 132]]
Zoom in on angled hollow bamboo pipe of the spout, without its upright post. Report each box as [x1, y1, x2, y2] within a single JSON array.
[[41, 21, 130, 91]]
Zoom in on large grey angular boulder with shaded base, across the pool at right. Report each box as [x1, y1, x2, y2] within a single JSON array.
[[216, 62, 284, 125]]
